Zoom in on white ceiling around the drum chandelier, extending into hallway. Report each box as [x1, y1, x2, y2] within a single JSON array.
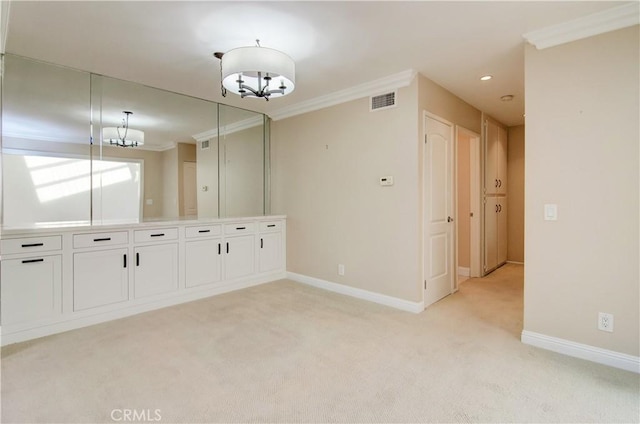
[[1, 1, 628, 126]]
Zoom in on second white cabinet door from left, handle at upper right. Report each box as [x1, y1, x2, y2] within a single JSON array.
[[73, 248, 129, 311]]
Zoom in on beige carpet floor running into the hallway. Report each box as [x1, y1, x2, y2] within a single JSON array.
[[1, 265, 640, 423]]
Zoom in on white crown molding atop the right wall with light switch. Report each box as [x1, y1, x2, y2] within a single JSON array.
[[522, 1, 640, 50]]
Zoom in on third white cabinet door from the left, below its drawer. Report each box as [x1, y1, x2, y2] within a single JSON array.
[[134, 243, 178, 299]]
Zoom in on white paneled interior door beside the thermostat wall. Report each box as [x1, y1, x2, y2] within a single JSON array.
[[423, 113, 455, 307]]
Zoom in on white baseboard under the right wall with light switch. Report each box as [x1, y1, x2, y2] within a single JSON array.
[[520, 330, 640, 374]]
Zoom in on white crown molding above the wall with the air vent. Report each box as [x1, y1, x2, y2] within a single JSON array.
[[269, 69, 417, 121]]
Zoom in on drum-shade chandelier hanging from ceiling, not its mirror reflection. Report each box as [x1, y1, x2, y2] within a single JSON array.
[[213, 40, 295, 101]]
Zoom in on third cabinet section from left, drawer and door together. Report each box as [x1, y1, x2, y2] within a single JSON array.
[[133, 228, 178, 299]]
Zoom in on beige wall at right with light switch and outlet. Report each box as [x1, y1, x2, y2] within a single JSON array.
[[524, 25, 640, 356]]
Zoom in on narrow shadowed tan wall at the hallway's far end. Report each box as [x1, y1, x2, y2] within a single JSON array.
[[507, 125, 525, 262]]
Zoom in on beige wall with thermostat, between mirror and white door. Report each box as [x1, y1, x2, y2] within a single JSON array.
[[271, 80, 422, 302]]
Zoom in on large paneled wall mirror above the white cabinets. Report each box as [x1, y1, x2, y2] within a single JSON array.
[[2, 55, 269, 228]]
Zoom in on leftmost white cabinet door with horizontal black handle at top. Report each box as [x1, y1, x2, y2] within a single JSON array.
[[0, 255, 62, 326]]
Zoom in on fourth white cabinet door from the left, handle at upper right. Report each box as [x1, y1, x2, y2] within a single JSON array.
[[185, 239, 222, 287]]
